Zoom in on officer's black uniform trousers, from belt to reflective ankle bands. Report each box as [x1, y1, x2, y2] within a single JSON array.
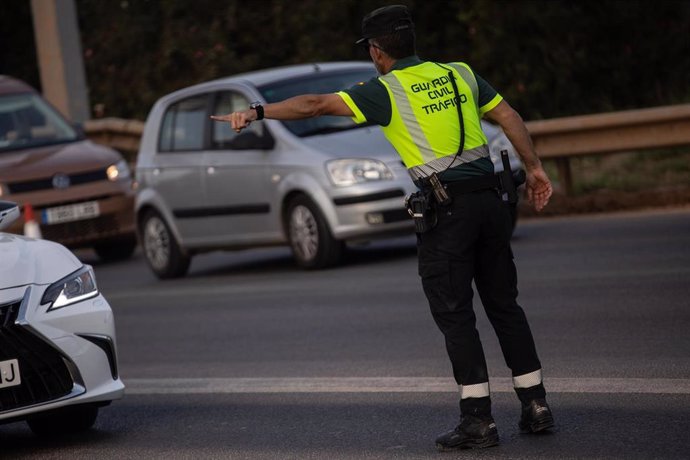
[[418, 190, 543, 408]]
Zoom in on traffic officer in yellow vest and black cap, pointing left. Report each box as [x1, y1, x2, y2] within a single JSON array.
[[213, 5, 554, 450]]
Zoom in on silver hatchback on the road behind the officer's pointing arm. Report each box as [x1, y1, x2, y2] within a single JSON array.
[[135, 62, 520, 278]]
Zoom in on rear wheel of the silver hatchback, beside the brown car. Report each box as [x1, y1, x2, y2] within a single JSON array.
[[139, 210, 191, 279]]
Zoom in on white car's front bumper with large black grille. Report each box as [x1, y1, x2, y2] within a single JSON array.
[[0, 285, 124, 423]]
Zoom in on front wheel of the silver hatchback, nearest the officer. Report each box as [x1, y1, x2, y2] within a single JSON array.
[[286, 195, 345, 269]]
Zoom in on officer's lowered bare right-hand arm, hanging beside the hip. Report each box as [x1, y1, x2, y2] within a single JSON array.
[[485, 101, 553, 211]]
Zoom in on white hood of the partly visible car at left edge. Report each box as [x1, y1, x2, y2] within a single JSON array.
[[0, 232, 83, 289]]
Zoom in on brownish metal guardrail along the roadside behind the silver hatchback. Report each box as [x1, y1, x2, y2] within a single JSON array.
[[84, 104, 690, 194]]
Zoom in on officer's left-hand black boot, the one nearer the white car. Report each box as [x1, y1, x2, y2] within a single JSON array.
[[436, 415, 498, 452]]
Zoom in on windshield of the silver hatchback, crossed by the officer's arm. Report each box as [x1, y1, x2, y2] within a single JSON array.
[[259, 68, 376, 137]]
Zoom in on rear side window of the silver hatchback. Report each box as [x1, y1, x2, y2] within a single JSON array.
[[158, 94, 208, 152]]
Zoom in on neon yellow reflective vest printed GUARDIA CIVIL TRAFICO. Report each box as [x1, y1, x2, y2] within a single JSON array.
[[379, 62, 489, 179]]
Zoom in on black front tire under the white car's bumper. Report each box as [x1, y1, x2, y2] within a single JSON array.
[[26, 404, 98, 437]]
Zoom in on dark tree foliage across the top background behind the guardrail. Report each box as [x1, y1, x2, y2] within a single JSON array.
[[0, 0, 690, 119]]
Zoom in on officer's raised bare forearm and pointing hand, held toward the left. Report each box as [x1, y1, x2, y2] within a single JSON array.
[[211, 94, 354, 132]]
